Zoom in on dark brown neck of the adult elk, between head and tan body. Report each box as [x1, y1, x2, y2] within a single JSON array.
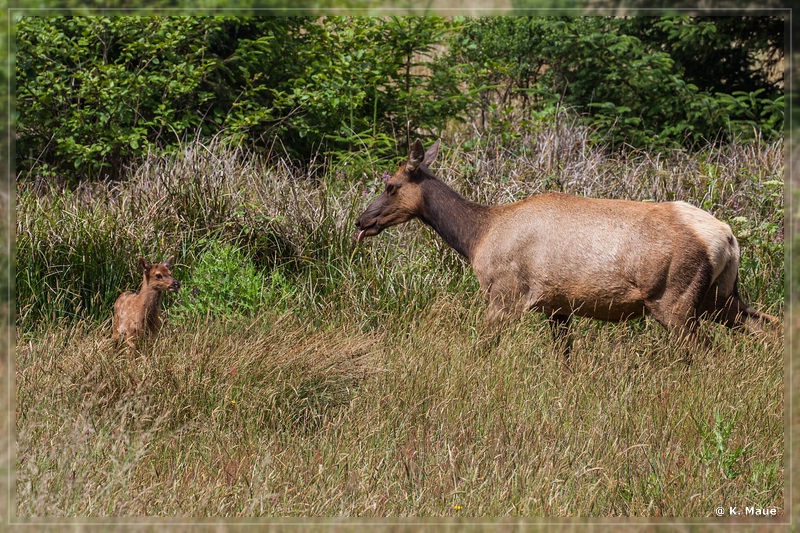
[[419, 176, 491, 261]]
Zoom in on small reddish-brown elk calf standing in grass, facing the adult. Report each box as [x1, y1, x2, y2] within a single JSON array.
[[112, 257, 181, 348]]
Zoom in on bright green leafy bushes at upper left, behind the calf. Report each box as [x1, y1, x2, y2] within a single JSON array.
[[16, 17, 476, 183]]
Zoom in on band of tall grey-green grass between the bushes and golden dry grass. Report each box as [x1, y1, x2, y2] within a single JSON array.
[[16, 121, 783, 329]]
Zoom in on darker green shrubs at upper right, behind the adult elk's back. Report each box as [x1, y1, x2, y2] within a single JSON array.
[[450, 17, 784, 148]]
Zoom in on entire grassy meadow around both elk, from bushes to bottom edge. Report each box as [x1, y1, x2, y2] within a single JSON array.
[[15, 117, 786, 522]]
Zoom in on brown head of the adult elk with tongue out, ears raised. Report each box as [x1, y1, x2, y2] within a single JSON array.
[[356, 139, 439, 242]]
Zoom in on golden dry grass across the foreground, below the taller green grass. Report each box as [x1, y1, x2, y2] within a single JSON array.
[[17, 299, 785, 517]]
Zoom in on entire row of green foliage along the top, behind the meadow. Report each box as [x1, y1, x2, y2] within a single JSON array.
[[16, 16, 783, 181]]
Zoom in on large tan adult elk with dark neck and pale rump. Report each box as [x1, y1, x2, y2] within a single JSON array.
[[356, 140, 777, 356]]
